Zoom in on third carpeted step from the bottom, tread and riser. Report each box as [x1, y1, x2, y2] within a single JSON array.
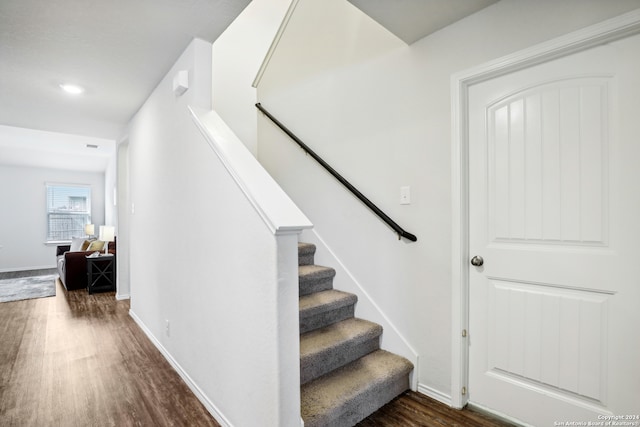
[[298, 289, 358, 334]]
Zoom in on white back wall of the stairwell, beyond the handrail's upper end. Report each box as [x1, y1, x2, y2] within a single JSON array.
[[212, 0, 291, 156]]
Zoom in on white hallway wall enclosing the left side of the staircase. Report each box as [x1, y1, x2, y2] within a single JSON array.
[[128, 40, 300, 427]]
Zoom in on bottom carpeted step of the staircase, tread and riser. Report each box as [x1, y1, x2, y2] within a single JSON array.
[[301, 350, 413, 427]]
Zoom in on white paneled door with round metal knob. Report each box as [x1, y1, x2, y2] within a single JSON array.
[[469, 32, 640, 426]]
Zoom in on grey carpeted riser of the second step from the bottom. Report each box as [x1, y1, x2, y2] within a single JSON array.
[[300, 336, 380, 384]]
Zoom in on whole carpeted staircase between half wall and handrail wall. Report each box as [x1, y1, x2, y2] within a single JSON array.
[[298, 243, 413, 427]]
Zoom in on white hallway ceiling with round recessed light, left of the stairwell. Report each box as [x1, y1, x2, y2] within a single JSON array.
[[0, 0, 250, 170]]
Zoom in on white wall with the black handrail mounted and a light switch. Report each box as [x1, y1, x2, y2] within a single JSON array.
[[258, 0, 640, 401]]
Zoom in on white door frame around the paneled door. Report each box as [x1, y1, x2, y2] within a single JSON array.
[[451, 9, 640, 408]]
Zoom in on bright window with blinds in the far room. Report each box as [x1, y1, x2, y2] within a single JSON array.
[[47, 184, 91, 241]]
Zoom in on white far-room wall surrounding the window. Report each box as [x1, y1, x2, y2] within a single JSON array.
[[0, 165, 105, 271]]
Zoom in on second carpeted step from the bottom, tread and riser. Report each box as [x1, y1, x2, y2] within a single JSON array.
[[300, 318, 382, 384]]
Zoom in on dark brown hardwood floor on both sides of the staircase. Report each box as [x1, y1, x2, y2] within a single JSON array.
[[0, 281, 509, 427]]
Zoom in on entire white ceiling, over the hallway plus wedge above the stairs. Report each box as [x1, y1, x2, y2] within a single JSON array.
[[0, 0, 497, 171]]
